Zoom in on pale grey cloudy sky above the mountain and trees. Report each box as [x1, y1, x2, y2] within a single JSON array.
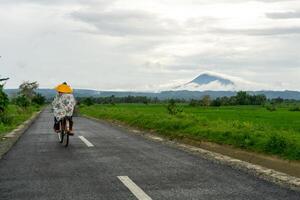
[[0, 0, 300, 90]]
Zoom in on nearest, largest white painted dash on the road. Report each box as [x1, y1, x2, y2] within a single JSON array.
[[118, 176, 152, 200]]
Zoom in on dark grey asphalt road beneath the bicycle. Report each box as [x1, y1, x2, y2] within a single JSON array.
[[0, 110, 300, 200]]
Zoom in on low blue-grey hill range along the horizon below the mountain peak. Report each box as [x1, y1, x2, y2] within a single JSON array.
[[5, 89, 300, 100]]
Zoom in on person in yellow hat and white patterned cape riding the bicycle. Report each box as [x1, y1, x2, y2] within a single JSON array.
[[52, 82, 76, 135]]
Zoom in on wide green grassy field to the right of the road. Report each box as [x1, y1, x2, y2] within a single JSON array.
[[80, 104, 300, 160]]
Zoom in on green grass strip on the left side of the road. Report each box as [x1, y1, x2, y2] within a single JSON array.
[[0, 105, 40, 137]]
